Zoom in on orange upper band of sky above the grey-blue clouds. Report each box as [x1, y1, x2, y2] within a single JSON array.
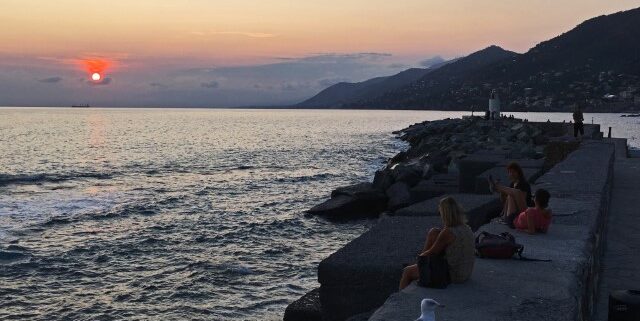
[[0, 0, 639, 65]]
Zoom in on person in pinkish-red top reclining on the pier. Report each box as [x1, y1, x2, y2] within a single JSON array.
[[513, 188, 551, 234]]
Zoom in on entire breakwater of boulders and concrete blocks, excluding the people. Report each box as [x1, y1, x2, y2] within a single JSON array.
[[285, 119, 614, 320]]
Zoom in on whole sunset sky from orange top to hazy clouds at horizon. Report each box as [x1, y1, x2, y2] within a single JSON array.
[[0, 0, 640, 107]]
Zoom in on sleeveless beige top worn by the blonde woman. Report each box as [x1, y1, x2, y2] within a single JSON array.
[[444, 224, 476, 283]]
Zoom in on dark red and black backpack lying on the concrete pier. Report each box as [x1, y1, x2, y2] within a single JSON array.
[[476, 232, 551, 262]]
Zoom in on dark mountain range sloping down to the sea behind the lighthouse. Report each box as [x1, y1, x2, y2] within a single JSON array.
[[304, 8, 640, 111]]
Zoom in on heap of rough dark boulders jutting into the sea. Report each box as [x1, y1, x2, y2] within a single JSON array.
[[308, 117, 550, 220]]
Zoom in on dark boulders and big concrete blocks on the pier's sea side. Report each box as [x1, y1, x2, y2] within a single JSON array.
[[284, 117, 584, 321]]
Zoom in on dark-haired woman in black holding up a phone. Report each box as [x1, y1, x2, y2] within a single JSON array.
[[489, 162, 534, 228]]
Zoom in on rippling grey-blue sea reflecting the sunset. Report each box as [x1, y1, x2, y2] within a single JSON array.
[[0, 107, 640, 320]]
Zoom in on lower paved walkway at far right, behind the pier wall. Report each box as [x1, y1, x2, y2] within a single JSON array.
[[593, 149, 640, 321]]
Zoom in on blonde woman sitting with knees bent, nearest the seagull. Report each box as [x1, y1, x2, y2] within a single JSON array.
[[400, 197, 475, 290]]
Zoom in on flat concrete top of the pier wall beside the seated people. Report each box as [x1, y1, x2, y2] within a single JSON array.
[[369, 141, 614, 321]]
